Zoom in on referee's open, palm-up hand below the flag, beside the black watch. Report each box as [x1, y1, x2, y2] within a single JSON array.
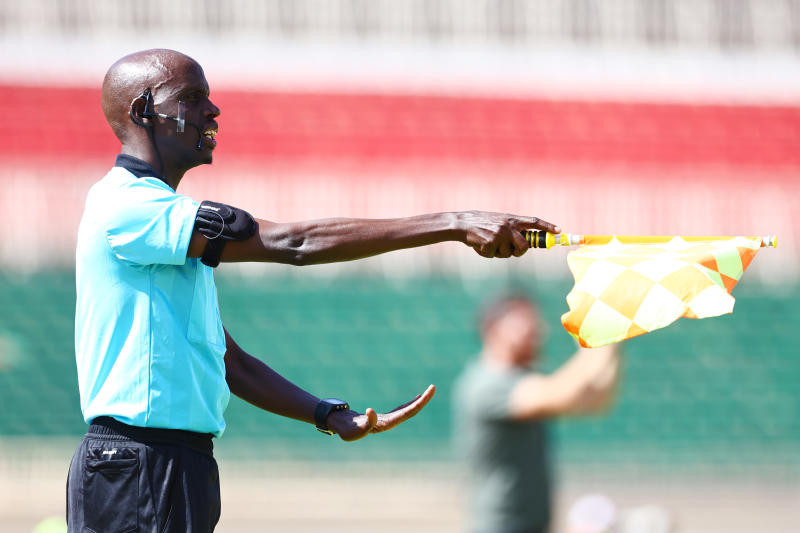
[[328, 385, 436, 441]]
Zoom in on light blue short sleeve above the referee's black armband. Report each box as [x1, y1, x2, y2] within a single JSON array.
[[106, 178, 200, 265]]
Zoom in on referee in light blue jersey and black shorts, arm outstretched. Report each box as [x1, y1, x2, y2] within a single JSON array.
[[67, 50, 558, 533]]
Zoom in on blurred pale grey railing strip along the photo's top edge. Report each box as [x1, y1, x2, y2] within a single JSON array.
[[0, 0, 800, 51]]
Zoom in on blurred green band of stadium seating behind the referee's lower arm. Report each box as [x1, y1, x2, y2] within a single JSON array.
[[0, 271, 800, 476]]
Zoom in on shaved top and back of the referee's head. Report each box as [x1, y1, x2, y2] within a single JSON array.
[[103, 48, 202, 144]]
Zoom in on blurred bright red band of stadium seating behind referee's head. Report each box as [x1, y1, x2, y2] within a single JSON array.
[[0, 85, 800, 167]]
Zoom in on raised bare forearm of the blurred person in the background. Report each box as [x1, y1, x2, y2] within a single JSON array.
[[509, 344, 620, 420]]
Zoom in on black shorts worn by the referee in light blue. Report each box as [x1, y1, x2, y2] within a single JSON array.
[[67, 417, 220, 533]]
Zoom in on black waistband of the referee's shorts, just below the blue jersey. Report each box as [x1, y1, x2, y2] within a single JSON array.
[[87, 416, 214, 456]]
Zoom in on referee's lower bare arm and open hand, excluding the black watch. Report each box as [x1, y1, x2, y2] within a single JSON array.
[[225, 330, 436, 441]]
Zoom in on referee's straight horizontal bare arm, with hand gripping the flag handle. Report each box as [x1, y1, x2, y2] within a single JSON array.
[[188, 211, 560, 265]]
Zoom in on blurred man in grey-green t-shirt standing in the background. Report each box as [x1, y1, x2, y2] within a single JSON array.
[[453, 294, 620, 533]]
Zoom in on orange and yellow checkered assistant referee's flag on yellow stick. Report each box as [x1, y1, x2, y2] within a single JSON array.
[[559, 236, 774, 347]]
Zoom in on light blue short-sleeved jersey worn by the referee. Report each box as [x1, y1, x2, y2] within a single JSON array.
[[75, 162, 230, 436]]
